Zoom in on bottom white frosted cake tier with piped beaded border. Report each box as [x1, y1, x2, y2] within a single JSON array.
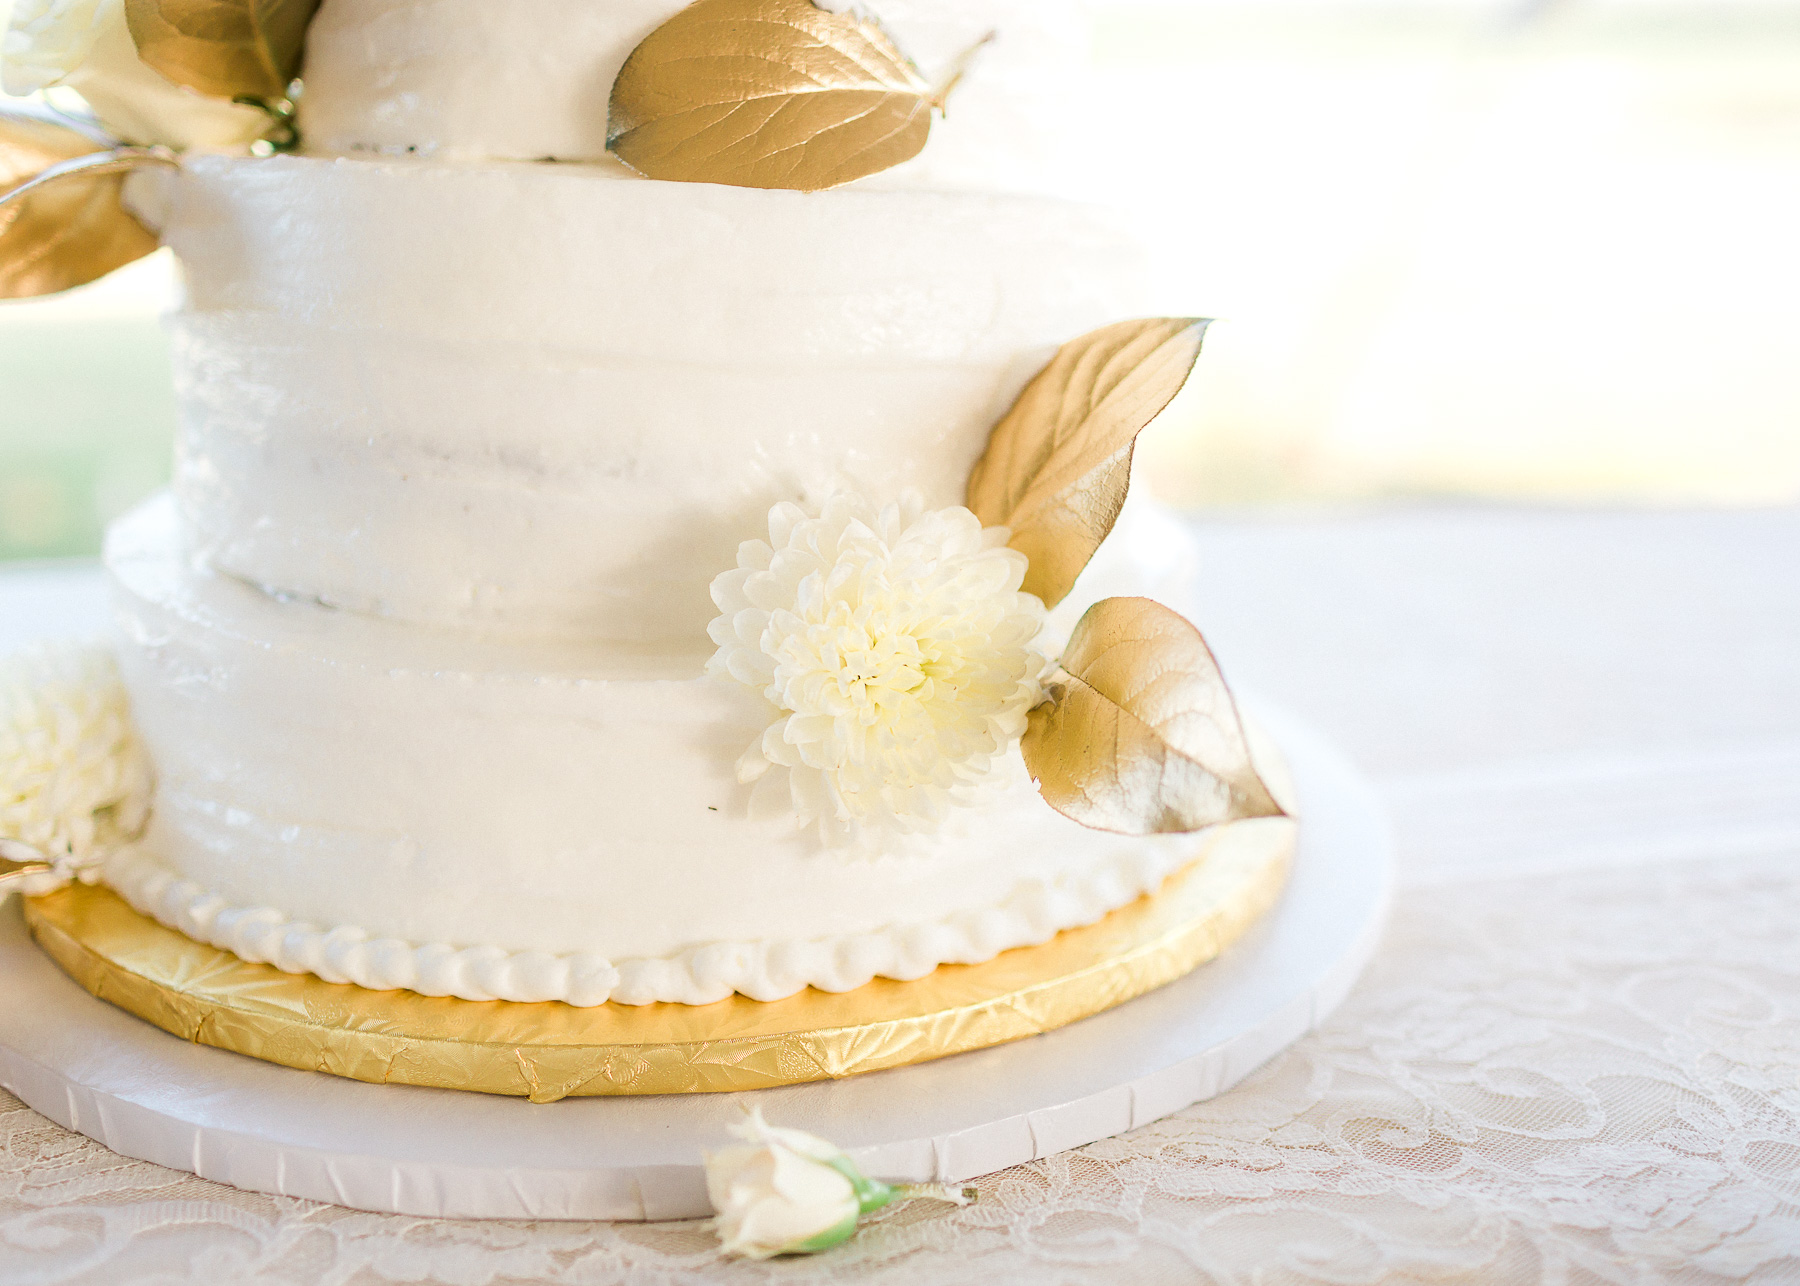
[[106, 499, 1285, 1005]]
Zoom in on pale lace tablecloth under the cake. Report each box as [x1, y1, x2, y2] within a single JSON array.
[[0, 510, 1800, 1286]]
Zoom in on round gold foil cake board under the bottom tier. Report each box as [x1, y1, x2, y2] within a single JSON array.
[[25, 818, 1294, 1102]]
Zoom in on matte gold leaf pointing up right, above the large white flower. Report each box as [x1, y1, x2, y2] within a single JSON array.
[[968, 317, 1208, 607]]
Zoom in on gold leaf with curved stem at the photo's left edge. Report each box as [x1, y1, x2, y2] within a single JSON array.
[[0, 112, 173, 299]]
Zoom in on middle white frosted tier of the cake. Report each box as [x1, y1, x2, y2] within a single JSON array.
[[131, 157, 1147, 641]]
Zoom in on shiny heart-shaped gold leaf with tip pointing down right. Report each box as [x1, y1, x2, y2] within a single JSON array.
[[1021, 598, 1283, 836]]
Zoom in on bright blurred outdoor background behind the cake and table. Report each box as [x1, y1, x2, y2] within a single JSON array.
[[0, 0, 1800, 558]]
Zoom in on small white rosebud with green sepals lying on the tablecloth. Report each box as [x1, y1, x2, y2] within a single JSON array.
[[706, 1108, 968, 1259]]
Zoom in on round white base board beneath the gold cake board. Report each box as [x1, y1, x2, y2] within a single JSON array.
[[0, 704, 1391, 1219]]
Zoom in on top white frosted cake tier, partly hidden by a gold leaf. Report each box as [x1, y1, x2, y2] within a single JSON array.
[[301, 0, 1085, 191]]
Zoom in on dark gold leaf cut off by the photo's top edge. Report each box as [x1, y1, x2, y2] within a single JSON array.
[[124, 0, 319, 101]]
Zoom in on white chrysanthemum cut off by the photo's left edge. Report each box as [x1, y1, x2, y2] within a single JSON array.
[[0, 647, 151, 875]]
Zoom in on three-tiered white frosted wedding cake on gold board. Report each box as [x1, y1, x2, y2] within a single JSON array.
[[3, 0, 1296, 1007]]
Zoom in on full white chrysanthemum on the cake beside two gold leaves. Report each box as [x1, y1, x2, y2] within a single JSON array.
[[707, 494, 1044, 843]]
